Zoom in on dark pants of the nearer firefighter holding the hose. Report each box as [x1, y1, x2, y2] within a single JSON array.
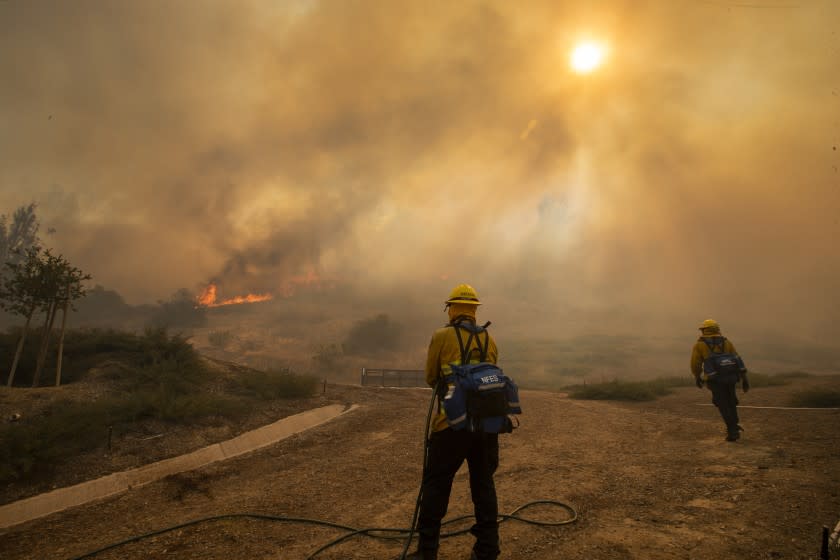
[[417, 428, 499, 560]]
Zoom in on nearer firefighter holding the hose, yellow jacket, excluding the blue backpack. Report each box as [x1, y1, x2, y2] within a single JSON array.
[[407, 284, 499, 560]]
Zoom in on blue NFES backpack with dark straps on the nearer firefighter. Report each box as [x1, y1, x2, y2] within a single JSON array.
[[442, 322, 522, 434]]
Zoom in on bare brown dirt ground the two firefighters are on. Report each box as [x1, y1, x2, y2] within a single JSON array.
[[0, 378, 840, 560]]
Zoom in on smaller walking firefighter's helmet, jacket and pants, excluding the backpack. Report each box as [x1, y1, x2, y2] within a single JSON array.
[[691, 319, 750, 441]]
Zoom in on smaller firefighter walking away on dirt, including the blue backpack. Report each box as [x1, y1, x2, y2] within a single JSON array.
[[691, 319, 750, 441]]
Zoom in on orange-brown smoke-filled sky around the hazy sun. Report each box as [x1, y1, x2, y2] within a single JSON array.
[[0, 0, 840, 340]]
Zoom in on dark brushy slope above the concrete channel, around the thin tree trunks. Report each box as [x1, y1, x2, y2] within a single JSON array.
[[0, 329, 318, 483]]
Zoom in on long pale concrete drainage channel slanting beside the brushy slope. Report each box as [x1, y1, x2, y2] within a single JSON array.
[[0, 404, 358, 528]]
